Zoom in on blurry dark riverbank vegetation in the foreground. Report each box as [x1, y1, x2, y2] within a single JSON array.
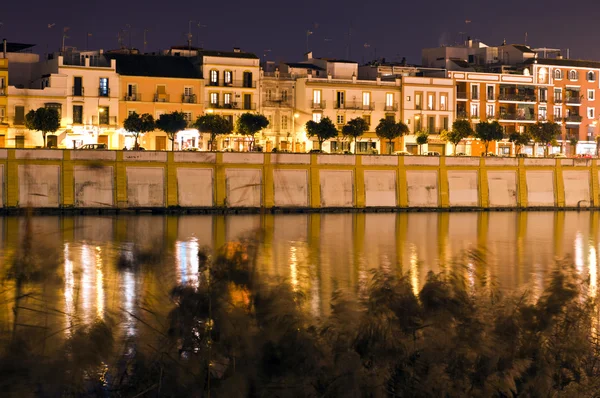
[[0, 232, 600, 397]]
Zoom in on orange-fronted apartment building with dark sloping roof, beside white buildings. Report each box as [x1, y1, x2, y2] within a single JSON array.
[[107, 54, 206, 150]]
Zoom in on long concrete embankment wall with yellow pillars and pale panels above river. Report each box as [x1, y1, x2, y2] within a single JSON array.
[[0, 149, 600, 210]]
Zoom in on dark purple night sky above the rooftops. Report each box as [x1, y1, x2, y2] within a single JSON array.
[[0, 0, 600, 63]]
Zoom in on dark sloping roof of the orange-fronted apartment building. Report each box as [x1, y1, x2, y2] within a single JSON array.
[[106, 54, 202, 79]]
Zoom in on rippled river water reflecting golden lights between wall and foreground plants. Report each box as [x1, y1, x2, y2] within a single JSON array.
[[0, 212, 600, 348]]
